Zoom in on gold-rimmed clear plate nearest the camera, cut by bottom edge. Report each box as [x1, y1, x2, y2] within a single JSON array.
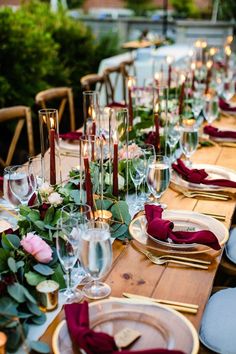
[[52, 299, 199, 354]]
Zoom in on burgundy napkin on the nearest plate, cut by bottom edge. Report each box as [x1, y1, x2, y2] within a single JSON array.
[[64, 301, 183, 354]]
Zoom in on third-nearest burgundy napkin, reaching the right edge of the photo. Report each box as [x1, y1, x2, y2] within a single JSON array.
[[172, 159, 236, 188]]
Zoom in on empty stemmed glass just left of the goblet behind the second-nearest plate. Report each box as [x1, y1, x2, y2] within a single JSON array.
[[129, 149, 146, 212]]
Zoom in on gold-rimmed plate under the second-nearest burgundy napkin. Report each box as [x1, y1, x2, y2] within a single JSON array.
[[129, 210, 229, 254]]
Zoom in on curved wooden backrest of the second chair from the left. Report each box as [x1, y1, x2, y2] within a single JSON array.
[[35, 87, 76, 131]]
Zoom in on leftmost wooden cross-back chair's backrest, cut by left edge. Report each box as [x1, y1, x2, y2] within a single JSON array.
[[0, 106, 34, 167]]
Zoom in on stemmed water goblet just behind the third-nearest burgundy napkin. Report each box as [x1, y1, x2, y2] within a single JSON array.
[[180, 125, 198, 166]]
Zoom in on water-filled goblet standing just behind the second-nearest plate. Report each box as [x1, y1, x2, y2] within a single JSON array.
[[147, 155, 170, 208]]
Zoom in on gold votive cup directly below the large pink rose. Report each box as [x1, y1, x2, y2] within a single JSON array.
[[36, 280, 59, 311]]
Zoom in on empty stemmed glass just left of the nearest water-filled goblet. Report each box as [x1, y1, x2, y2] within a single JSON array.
[[56, 211, 83, 303]]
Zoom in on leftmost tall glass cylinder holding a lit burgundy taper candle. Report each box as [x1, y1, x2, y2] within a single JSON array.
[[39, 109, 62, 185]]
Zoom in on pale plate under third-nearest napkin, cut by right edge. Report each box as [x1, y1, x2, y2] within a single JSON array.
[[171, 164, 236, 192]]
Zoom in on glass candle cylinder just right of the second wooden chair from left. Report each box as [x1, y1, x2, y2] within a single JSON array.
[[83, 91, 100, 135]]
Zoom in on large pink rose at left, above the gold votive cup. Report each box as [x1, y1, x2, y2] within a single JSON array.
[[20, 232, 52, 263]]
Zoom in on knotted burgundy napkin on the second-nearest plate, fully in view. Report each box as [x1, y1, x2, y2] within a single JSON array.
[[144, 204, 221, 250]]
